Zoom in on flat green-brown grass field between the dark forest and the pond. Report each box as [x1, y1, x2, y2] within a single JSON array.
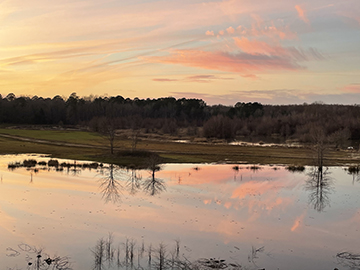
[[0, 129, 359, 166]]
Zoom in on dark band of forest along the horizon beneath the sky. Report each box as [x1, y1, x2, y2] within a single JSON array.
[[0, 93, 360, 146]]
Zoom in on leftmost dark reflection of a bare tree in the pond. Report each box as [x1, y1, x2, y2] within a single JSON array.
[[99, 164, 123, 203]]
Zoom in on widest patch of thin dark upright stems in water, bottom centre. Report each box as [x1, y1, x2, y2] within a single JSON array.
[[90, 233, 265, 270]]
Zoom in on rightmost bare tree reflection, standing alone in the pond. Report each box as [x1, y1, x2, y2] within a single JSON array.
[[305, 166, 334, 212]]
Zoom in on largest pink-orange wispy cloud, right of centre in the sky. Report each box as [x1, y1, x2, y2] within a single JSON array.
[[147, 15, 325, 78]]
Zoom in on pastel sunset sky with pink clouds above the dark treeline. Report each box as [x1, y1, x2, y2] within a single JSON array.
[[0, 0, 360, 105]]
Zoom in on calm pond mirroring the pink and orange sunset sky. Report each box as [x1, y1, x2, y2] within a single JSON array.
[[0, 155, 360, 270]]
